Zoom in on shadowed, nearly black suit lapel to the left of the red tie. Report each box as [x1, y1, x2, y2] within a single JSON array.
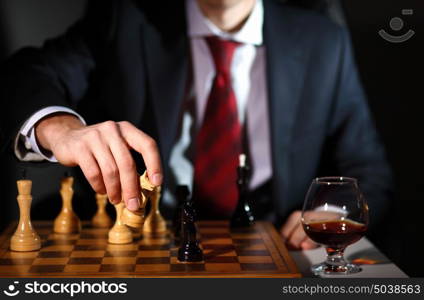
[[143, 1, 189, 161]]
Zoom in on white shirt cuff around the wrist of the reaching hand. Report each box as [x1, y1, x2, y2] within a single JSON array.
[[14, 106, 86, 162]]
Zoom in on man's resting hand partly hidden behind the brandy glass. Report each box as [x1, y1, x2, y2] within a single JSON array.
[[280, 210, 318, 250]]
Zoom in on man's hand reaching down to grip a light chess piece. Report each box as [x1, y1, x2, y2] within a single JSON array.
[[35, 114, 163, 210]]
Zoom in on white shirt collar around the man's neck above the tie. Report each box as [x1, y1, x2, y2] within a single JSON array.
[[186, 0, 264, 46]]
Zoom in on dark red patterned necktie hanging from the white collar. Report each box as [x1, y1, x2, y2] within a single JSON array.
[[194, 37, 242, 217]]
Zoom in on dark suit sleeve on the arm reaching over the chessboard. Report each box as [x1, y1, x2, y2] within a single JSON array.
[[0, 1, 115, 154]]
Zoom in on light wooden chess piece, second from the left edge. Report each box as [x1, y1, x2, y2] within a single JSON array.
[[53, 176, 81, 233]]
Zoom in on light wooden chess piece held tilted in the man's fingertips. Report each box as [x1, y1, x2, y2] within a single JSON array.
[[122, 172, 155, 228]]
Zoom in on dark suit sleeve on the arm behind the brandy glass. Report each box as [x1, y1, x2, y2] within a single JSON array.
[[326, 29, 393, 228]]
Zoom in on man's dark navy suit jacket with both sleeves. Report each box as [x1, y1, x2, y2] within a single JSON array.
[[1, 0, 391, 230]]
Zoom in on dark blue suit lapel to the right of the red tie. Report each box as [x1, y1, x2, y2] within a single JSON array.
[[264, 1, 305, 211]]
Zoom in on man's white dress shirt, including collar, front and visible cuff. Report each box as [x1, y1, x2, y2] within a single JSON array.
[[15, 0, 272, 189]]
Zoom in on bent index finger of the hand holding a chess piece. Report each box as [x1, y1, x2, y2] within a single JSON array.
[[118, 121, 163, 186]]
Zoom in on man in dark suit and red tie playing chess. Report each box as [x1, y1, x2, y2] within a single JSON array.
[[1, 0, 391, 249]]
